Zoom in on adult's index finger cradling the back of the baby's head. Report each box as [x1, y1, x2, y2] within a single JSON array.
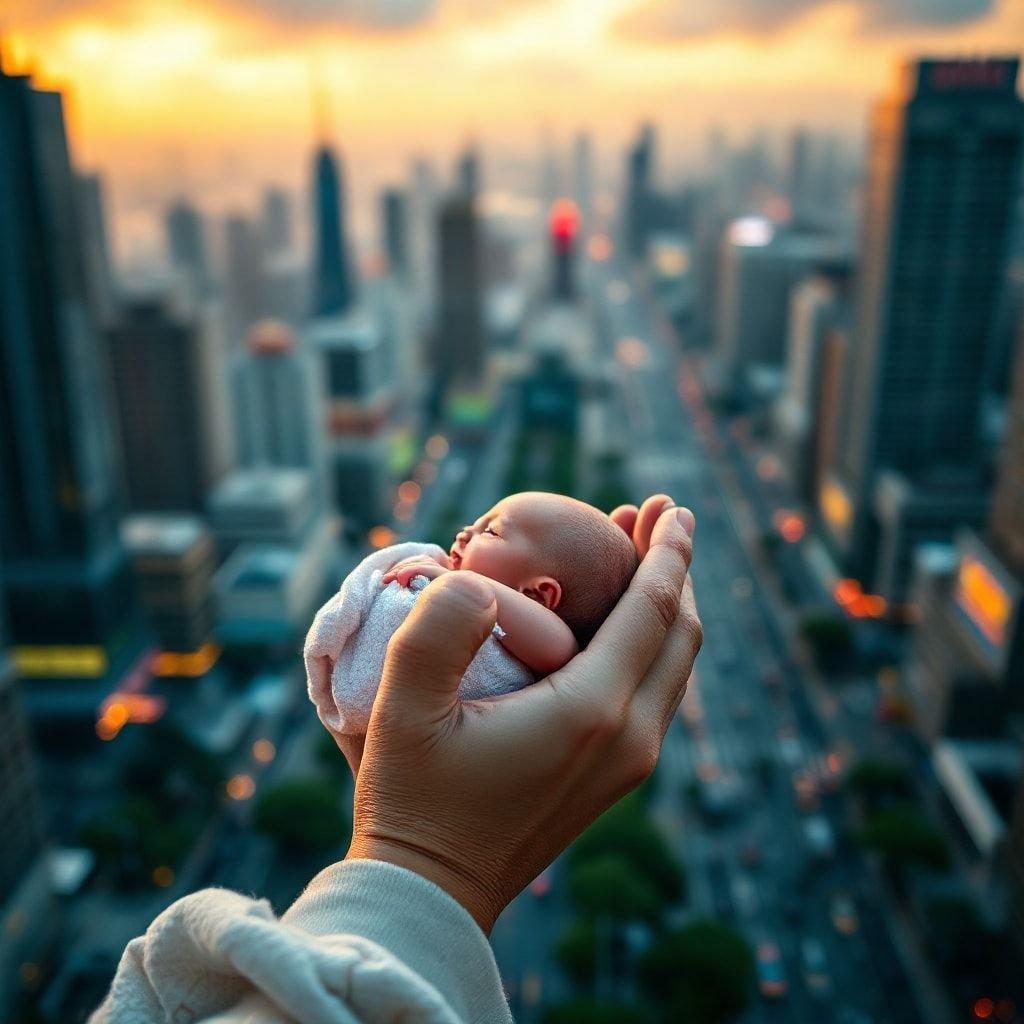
[[586, 503, 693, 696]]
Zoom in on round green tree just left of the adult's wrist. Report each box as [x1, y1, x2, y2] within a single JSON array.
[[255, 777, 349, 853]]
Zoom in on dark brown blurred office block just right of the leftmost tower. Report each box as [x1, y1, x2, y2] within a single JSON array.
[[108, 298, 229, 512]]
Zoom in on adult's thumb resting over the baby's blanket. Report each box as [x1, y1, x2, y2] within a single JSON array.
[[374, 572, 497, 721]]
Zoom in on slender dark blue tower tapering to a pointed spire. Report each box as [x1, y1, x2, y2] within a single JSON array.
[[312, 144, 355, 316]]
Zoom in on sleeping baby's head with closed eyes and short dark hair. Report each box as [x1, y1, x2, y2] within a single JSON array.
[[450, 492, 637, 647]]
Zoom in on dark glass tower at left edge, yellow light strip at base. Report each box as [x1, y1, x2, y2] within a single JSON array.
[[0, 69, 138, 714]]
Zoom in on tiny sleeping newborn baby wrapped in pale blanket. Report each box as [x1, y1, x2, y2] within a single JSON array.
[[303, 492, 638, 733]]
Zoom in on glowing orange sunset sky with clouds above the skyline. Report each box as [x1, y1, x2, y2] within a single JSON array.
[[0, 0, 1024, 262]]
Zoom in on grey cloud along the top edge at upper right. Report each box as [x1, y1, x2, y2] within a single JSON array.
[[620, 0, 996, 41]]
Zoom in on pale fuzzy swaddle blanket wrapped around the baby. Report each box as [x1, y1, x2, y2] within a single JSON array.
[[302, 541, 535, 734]]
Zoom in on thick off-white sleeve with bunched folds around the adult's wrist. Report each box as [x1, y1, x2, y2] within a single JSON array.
[[90, 860, 512, 1024]]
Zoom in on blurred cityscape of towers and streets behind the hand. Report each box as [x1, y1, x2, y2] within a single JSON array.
[[0, 6, 1024, 1024]]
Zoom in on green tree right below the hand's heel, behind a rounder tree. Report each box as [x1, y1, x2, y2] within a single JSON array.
[[568, 794, 686, 903]]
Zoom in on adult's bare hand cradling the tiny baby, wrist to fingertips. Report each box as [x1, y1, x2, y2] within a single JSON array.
[[346, 498, 701, 932]]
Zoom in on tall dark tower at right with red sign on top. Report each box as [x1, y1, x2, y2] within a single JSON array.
[[821, 59, 1024, 600]]
